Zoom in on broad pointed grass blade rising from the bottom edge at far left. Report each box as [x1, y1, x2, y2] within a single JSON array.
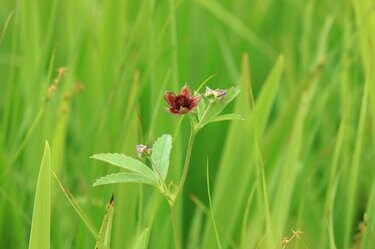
[[29, 142, 51, 249]]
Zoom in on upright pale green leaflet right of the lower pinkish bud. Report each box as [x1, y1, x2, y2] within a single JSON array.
[[151, 135, 172, 181]]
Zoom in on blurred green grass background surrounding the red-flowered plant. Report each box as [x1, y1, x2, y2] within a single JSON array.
[[0, 0, 375, 249]]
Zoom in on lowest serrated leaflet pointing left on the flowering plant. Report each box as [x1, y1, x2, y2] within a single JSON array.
[[93, 172, 159, 187]]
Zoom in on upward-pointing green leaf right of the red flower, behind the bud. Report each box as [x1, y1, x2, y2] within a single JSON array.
[[199, 87, 240, 127]]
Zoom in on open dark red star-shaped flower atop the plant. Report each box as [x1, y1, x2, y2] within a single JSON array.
[[164, 86, 201, 115]]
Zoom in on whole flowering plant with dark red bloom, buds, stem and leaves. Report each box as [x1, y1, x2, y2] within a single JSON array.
[[91, 86, 242, 248]]
